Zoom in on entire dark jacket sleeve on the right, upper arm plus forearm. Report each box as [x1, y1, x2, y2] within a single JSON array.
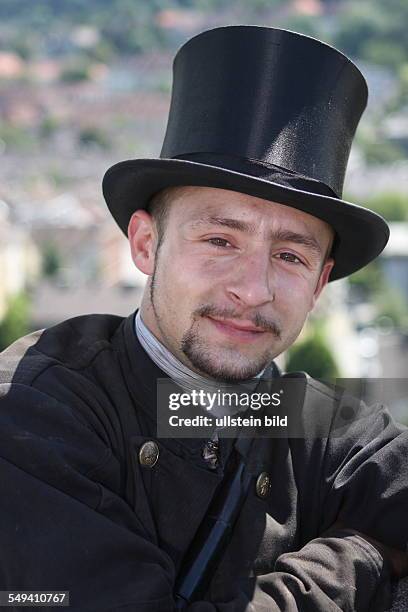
[[178, 398, 408, 612]]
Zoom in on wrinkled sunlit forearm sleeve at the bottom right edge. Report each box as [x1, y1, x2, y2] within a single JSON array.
[[180, 529, 391, 612]]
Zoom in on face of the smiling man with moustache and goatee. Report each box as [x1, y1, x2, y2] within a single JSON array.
[[129, 187, 333, 381]]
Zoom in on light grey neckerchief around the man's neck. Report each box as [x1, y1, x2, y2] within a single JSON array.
[[135, 310, 265, 416]]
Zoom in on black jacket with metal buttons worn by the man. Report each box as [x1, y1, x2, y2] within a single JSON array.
[[0, 315, 408, 612]]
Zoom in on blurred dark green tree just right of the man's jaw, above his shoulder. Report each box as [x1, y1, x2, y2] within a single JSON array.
[[285, 326, 339, 381]]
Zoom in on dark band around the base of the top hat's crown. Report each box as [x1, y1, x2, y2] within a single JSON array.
[[171, 152, 341, 199]]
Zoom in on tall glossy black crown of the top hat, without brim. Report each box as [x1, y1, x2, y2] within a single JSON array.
[[160, 26, 368, 197]]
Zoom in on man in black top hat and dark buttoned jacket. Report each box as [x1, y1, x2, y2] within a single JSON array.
[[0, 26, 408, 612]]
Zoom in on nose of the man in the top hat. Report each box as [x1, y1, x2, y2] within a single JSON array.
[[226, 253, 275, 307]]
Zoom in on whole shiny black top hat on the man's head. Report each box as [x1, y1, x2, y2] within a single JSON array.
[[103, 26, 389, 280]]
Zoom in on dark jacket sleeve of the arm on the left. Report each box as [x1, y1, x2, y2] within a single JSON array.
[[0, 384, 174, 612]]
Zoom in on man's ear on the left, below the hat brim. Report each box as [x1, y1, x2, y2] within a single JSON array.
[[128, 210, 157, 276]]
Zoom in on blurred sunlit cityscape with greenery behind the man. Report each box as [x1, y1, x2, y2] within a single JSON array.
[[0, 0, 408, 422]]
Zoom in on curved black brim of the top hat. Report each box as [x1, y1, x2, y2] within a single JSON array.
[[103, 159, 389, 281]]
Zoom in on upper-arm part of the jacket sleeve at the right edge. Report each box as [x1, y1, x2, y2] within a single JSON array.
[[321, 403, 408, 551]]
